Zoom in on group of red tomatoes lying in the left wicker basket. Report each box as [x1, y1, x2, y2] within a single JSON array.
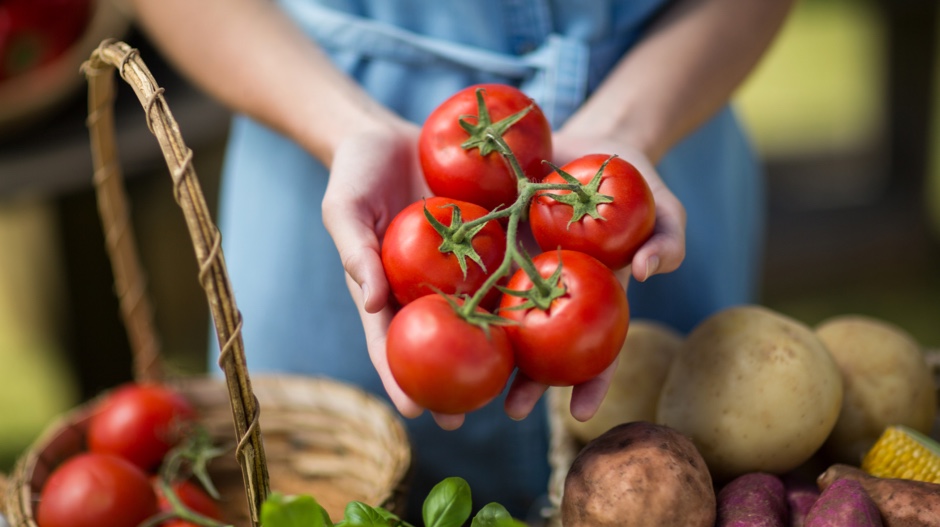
[[36, 383, 222, 527]]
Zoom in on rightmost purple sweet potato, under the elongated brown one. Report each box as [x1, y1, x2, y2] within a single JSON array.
[[805, 478, 884, 527]]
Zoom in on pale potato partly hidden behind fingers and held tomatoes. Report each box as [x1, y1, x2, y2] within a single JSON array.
[[558, 319, 682, 443]]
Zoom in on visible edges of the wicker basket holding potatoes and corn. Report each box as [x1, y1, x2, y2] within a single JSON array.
[[541, 349, 940, 527]]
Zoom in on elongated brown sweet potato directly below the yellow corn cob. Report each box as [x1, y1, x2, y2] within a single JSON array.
[[816, 463, 940, 527]]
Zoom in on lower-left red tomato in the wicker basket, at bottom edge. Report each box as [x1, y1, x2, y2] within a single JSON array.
[[36, 452, 157, 527]]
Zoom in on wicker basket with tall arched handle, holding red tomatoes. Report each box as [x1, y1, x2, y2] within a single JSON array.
[[3, 41, 411, 527]]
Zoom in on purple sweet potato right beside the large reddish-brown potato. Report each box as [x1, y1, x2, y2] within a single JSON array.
[[715, 472, 789, 527]]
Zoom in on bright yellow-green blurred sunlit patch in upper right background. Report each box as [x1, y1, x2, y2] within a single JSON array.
[[736, 0, 883, 158]]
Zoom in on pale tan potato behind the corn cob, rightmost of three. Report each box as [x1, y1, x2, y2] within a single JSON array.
[[816, 315, 937, 464]]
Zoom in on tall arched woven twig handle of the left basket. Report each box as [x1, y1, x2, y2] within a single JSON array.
[[82, 40, 270, 526]]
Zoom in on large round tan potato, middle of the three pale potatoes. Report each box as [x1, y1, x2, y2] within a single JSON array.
[[656, 305, 842, 480]]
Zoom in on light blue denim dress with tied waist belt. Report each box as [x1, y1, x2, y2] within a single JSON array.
[[213, 0, 763, 518]]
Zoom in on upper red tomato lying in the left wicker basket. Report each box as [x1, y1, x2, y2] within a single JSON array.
[[87, 383, 196, 471]]
